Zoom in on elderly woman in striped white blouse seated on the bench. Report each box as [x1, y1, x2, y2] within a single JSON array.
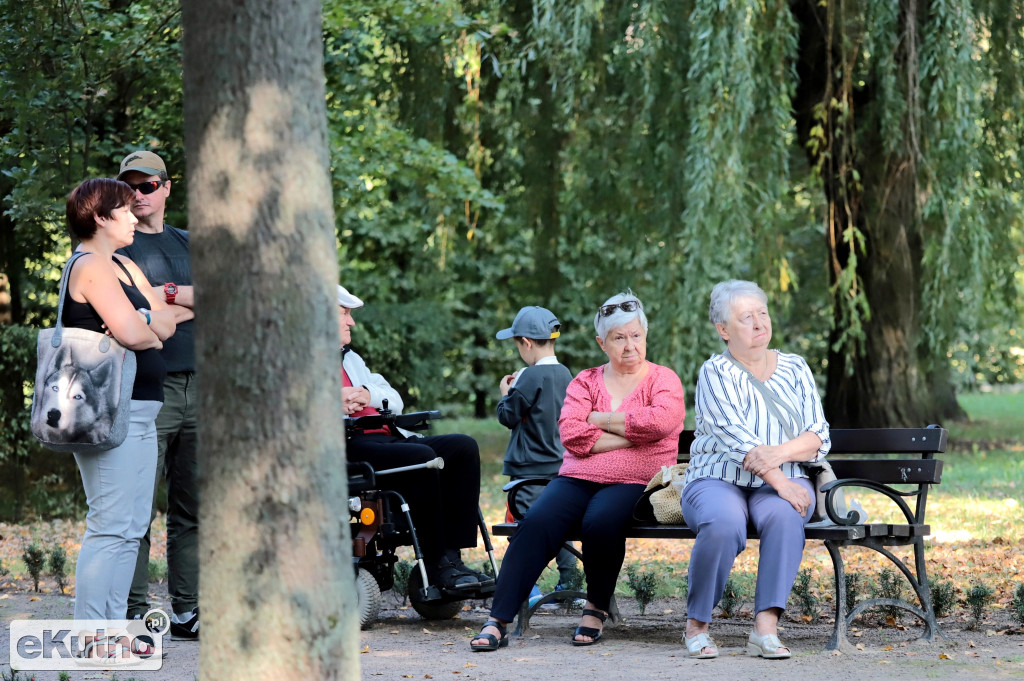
[[682, 280, 830, 658]]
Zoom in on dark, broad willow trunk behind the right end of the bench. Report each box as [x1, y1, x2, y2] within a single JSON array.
[[793, 0, 963, 427]]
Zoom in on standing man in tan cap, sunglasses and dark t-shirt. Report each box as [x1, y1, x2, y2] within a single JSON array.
[[118, 150, 199, 640]]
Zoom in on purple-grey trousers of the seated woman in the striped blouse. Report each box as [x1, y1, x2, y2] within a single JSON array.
[[682, 478, 814, 622]]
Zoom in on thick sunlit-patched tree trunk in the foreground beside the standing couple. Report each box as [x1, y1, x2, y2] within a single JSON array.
[[182, 0, 359, 681]]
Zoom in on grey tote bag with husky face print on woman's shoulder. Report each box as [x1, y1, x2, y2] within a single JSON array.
[[32, 253, 135, 454]]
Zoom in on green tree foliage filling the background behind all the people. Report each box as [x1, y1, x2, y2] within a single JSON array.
[[0, 0, 1024, 516]]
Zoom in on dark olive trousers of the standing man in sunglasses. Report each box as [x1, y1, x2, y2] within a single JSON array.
[[127, 372, 199, 619]]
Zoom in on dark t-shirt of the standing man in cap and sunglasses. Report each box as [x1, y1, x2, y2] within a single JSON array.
[[118, 224, 196, 372]]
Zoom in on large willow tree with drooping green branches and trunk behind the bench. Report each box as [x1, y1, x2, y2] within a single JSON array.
[[475, 0, 1024, 425]]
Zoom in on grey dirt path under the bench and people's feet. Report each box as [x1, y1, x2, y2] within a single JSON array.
[[0, 585, 1024, 681]]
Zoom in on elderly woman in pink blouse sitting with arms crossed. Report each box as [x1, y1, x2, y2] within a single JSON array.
[[470, 292, 685, 650]]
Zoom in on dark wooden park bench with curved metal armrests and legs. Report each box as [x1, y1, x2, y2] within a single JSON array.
[[493, 426, 948, 650]]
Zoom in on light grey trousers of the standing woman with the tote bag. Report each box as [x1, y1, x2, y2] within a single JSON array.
[[75, 399, 161, 620]]
